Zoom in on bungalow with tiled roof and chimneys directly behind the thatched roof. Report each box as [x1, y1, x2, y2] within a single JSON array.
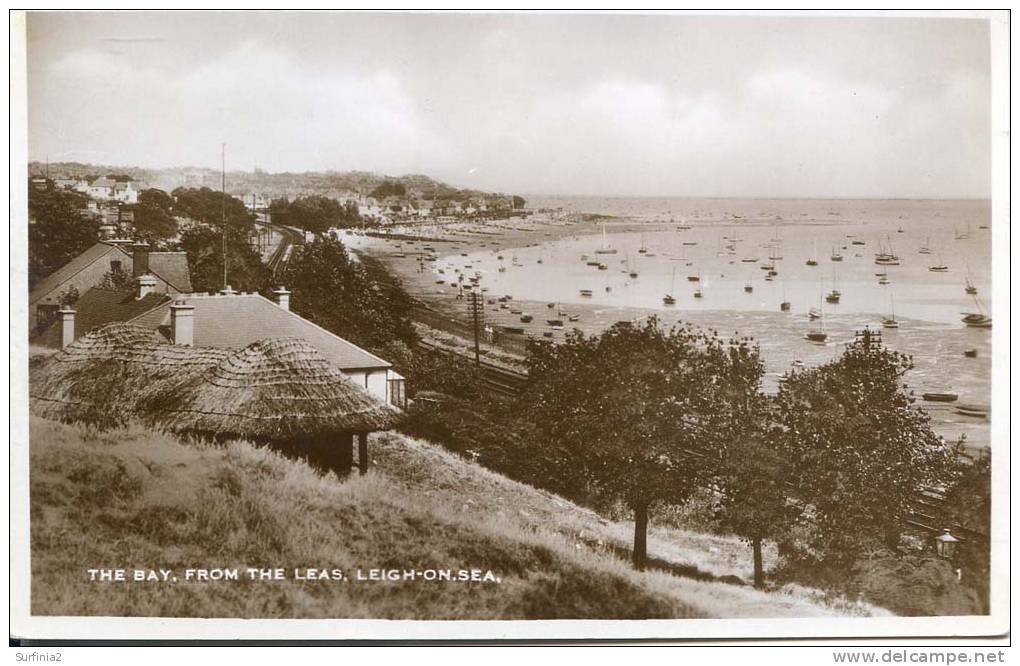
[[38, 285, 406, 407]]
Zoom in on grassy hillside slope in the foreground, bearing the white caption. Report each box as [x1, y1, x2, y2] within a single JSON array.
[[31, 417, 881, 619]]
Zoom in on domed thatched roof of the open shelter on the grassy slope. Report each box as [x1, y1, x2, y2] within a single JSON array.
[[30, 323, 400, 440]]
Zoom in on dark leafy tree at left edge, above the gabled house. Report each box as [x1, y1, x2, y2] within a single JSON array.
[[29, 181, 99, 289]]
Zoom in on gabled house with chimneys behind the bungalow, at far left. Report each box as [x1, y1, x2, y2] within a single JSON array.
[[29, 240, 192, 327]]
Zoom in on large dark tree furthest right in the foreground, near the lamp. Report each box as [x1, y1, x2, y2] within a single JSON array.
[[773, 334, 954, 563]]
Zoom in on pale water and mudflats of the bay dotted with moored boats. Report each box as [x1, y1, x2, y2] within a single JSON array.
[[341, 198, 991, 448]]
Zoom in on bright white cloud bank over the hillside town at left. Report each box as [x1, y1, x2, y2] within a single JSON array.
[[39, 41, 447, 170]]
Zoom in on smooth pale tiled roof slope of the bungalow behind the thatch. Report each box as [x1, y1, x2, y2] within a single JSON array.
[[145, 294, 390, 370]]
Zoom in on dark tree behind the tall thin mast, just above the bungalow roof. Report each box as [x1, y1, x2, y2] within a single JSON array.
[[181, 225, 269, 292]]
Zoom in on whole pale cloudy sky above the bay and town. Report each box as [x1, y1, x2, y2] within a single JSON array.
[[28, 13, 990, 197]]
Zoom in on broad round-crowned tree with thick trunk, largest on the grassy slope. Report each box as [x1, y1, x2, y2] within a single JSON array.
[[518, 317, 763, 568]]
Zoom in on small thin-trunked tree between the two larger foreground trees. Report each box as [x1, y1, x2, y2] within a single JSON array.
[[716, 436, 798, 587]]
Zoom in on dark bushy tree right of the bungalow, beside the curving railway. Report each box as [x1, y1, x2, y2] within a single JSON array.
[[281, 237, 417, 350]]
